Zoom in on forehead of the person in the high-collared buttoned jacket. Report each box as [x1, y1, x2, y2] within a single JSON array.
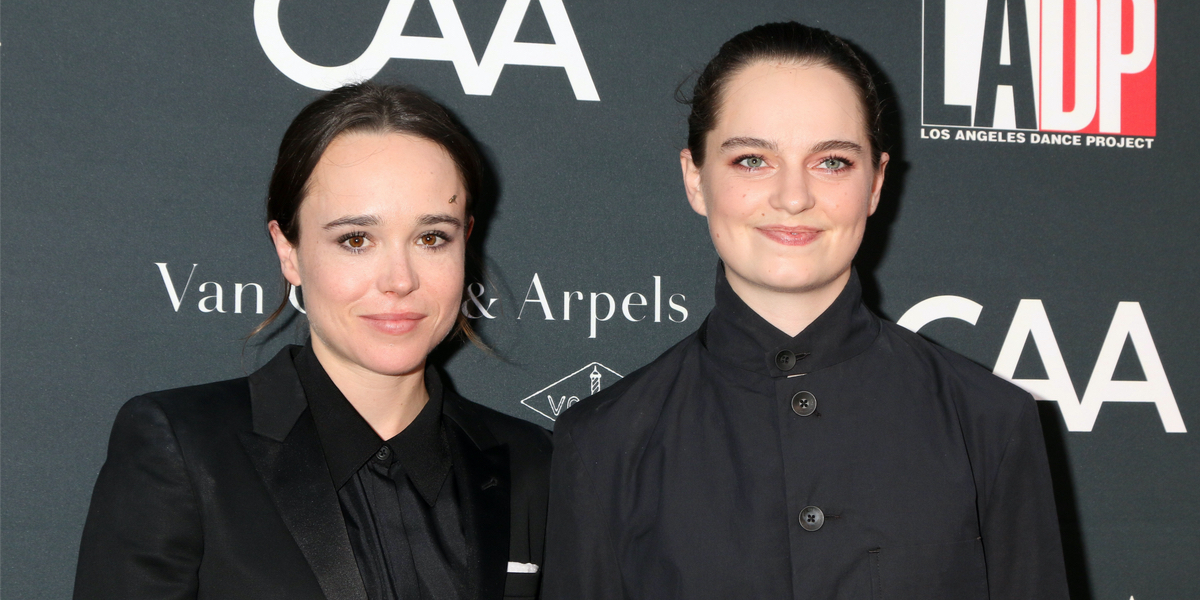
[[714, 61, 868, 148]]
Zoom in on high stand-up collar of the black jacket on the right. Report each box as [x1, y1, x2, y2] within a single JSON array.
[[701, 264, 880, 377]]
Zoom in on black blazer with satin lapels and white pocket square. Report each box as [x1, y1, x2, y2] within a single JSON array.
[[74, 348, 551, 600]]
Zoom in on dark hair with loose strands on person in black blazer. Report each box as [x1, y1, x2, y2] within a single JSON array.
[[251, 82, 482, 343]]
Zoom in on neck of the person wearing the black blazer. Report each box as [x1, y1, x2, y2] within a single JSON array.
[[312, 336, 430, 439]]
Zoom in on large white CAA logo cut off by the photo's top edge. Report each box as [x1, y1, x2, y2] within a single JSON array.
[[254, 0, 600, 101]]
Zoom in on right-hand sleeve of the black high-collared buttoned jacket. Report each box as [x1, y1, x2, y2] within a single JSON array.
[[980, 397, 1068, 600]]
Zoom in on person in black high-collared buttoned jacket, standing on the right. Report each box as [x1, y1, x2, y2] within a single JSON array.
[[542, 23, 1067, 600]]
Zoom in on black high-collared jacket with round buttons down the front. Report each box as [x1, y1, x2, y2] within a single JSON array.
[[542, 267, 1067, 600]]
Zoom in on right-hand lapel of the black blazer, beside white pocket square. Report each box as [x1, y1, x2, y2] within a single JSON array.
[[442, 390, 511, 600]]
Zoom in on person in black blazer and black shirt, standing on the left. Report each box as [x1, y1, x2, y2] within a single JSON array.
[[74, 83, 550, 600]]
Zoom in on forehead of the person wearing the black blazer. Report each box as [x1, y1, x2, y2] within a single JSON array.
[[301, 132, 466, 214]]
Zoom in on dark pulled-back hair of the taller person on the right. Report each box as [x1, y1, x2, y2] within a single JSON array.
[[685, 22, 883, 167]]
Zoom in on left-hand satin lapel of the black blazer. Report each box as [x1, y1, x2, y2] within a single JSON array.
[[234, 347, 367, 600]]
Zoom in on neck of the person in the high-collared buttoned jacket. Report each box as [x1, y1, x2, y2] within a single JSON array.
[[725, 265, 850, 337]]
